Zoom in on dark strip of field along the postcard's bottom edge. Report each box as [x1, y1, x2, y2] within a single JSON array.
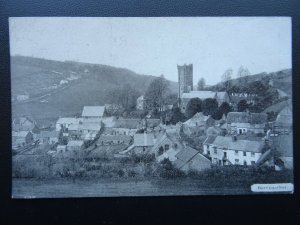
[[12, 178, 251, 198]]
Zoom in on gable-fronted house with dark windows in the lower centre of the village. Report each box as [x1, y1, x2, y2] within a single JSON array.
[[152, 130, 183, 162]]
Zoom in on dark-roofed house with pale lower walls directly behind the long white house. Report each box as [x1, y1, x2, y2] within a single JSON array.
[[227, 112, 267, 134]]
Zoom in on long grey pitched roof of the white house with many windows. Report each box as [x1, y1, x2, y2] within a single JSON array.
[[212, 136, 264, 153]]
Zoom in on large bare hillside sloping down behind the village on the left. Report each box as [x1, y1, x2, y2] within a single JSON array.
[[11, 56, 177, 126]]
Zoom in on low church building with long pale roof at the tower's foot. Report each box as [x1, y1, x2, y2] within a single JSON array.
[[180, 91, 229, 113]]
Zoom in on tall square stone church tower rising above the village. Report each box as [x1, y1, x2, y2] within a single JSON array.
[[177, 64, 193, 99]]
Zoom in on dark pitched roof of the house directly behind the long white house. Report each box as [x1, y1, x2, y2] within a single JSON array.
[[227, 112, 268, 124]]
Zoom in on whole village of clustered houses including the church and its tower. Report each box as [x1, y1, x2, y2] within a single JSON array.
[[12, 64, 293, 181]]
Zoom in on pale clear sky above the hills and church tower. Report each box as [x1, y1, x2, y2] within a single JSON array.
[[9, 17, 292, 85]]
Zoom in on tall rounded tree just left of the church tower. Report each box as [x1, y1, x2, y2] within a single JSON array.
[[145, 75, 169, 112]]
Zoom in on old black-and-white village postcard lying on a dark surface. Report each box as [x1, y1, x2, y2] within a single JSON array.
[[9, 17, 294, 198]]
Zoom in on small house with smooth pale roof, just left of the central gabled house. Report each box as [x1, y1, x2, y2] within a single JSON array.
[[132, 133, 154, 154]]
